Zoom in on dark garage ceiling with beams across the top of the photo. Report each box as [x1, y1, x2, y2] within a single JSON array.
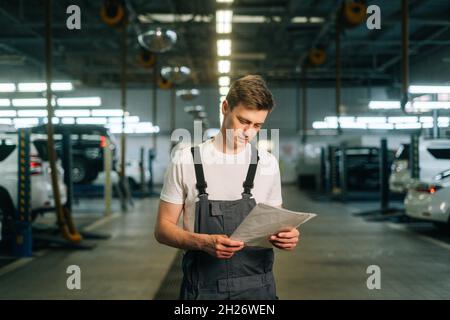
[[0, 0, 450, 87]]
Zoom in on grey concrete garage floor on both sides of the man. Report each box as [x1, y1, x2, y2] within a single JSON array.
[[0, 186, 450, 299]]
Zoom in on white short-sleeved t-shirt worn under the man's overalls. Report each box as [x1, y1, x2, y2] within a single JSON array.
[[160, 139, 282, 232]]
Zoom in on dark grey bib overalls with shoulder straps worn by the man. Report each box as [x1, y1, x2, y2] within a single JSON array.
[[180, 147, 277, 300]]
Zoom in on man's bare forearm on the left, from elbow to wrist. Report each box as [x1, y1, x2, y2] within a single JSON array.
[[155, 221, 208, 250]]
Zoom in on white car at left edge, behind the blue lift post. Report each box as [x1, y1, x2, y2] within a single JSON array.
[[0, 133, 67, 220]]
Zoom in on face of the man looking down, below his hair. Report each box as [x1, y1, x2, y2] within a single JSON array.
[[222, 100, 269, 146]]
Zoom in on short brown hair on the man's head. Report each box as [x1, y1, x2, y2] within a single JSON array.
[[226, 75, 274, 112]]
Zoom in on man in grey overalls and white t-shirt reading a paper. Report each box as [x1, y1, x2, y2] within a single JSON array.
[[155, 75, 299, 300]]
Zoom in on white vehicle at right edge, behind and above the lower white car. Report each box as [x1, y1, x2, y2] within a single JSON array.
[[389, 139, 450, 193]]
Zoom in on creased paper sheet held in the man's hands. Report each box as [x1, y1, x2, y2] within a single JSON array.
[[230, 203, 316, 248]]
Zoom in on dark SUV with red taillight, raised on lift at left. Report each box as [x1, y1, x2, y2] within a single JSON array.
[[33, 124, 116, 184]]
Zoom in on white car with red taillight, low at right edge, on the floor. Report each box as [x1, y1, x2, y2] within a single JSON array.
[[404, 169, 450, 225]]
